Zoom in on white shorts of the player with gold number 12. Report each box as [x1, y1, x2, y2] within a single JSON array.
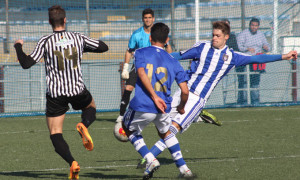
[[123, 108, 172, 134]]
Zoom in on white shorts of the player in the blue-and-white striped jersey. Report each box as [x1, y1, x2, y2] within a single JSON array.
[[170, 89, 205, 133]]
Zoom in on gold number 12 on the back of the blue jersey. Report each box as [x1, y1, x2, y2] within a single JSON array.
[[146, 64, 168, 93]]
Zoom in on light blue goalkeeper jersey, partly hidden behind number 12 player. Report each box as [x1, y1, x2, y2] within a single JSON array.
[[128, 27, 151, 52]]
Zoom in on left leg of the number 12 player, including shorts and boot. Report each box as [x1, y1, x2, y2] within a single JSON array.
[[123, 109, 160, 179]]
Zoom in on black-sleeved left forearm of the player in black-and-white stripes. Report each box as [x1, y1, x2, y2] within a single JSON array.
[[14, 43, 36, 69]]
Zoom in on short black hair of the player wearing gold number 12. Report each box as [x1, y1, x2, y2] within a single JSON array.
[[150, 22, 170, 44]]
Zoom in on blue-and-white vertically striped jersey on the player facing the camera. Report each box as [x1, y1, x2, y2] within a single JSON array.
[[180, 41, 251, 101]]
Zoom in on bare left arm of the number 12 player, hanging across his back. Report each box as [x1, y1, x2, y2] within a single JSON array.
[[137, 68, 167, 113]]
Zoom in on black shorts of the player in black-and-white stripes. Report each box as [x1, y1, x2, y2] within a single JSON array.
[[46, 89, 93, 117]]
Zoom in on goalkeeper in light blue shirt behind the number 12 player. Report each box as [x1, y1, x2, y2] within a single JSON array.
[[116, 8, 172, 122]]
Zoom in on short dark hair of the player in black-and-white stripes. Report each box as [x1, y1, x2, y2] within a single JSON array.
[[48, 5, 66, 28]]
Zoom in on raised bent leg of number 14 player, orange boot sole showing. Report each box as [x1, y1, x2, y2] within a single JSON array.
[[69, 89, 96, 151]]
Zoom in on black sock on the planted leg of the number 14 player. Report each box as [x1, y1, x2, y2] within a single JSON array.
[[50, 133, 75, 166]]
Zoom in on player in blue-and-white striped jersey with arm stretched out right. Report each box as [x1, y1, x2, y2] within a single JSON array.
[[144, 21, 297, 165]]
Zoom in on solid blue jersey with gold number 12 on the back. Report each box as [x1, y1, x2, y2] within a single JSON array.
[[129, 46, 188, 113]]
